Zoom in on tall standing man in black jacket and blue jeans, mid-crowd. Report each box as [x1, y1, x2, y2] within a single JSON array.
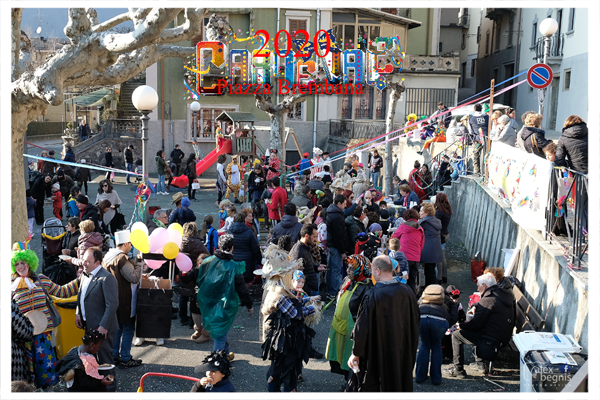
[[326, 194, 347, 301]]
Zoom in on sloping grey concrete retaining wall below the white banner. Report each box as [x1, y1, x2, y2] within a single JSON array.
[[445, 177, 588, 352]]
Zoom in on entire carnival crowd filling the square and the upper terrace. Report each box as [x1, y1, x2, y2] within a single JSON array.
[[16, 100, 587, 391]]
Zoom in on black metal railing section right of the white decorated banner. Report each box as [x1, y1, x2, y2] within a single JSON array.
[[544, 167, 589, 269]]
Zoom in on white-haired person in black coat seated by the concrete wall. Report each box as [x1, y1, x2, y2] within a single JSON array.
[[444, 272, 517, 379]]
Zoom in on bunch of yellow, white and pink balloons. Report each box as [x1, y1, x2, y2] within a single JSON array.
[[131, 222, 192, 272]]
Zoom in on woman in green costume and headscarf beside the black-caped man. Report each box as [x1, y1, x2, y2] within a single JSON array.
[[325, 255, 373, 380]]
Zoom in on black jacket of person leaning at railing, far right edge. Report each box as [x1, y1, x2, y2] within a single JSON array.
[[554, 122, 588, 174]]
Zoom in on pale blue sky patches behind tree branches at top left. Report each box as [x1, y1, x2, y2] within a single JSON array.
[[21, 8, 133, 39]]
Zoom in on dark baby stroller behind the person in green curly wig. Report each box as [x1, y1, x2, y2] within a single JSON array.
[[41, 217, 75, 285]]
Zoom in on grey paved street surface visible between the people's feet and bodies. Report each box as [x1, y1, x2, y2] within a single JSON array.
[[34, 161, 519, 392]]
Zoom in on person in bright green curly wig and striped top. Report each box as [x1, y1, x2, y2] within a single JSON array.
[[10, 250, 79, 388]]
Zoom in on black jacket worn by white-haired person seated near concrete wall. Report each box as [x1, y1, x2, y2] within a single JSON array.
[[460, 279, 517, 345]]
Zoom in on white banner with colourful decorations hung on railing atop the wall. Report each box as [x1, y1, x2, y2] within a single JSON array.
[[488, 143, 552, 231]]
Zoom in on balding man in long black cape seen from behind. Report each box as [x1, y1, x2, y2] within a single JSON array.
[[348, 256, 421, 392]]
